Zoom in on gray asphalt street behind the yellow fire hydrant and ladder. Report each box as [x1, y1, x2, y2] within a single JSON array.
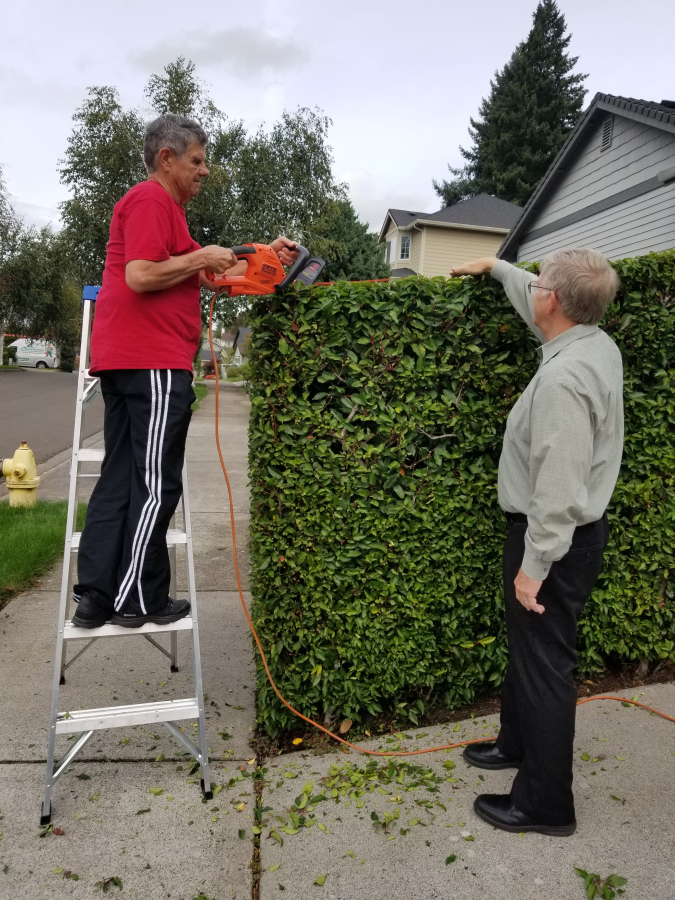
[[0, 369, 103, 463]]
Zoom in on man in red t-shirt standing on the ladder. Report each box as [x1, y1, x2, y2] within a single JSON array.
[[73, 114, 297, 628]]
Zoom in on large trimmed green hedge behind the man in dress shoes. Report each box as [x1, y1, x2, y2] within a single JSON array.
[[249, 252, 675, 733]]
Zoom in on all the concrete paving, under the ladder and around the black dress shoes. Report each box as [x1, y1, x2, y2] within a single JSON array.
[[0, 387, 675, 900]]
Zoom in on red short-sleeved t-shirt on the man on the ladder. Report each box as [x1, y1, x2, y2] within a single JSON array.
[[91, 181, 201, 373]]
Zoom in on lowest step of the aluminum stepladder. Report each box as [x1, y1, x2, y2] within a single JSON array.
[[56, 697, 199, 734]]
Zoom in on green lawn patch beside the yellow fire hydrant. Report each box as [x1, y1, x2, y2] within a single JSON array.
[[0, 500, 87, 607]]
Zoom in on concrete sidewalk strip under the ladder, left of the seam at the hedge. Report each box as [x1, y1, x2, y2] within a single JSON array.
[[0, 387, 255, 900]]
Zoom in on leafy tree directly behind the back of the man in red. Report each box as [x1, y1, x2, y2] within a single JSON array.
[[60, 87, 146, 284]]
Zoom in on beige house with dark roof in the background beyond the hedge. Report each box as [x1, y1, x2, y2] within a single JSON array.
[[380, 194, 522, 278]]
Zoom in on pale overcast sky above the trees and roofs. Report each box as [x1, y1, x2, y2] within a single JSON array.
[[0, 0, 675, 230]]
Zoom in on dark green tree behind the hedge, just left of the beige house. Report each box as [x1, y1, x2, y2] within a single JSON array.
[[321, 199, 391, 281]]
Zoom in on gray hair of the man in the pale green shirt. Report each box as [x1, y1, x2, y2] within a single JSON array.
[[540, 247, 619, 325]]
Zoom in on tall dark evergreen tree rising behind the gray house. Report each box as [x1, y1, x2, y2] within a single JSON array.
[[433, 0, 587, 206]]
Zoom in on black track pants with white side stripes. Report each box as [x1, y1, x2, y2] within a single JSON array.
[[74, 369, 195, 615]]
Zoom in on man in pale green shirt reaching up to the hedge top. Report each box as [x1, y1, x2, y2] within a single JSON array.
[[451, 249, 623, 836]]
